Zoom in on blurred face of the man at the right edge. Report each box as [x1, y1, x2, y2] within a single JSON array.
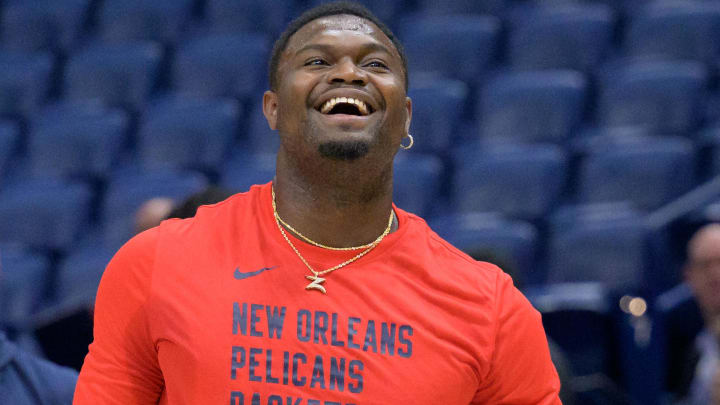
[[685, 225, 720, 321]]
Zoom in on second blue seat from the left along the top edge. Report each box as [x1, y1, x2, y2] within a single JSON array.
[[98, 0, 194, 43]]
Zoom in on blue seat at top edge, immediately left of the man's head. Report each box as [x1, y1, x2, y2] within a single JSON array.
[[205, 0, 295, 35]]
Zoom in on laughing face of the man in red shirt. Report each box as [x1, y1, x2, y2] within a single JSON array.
[[263, 15, 411, 160]]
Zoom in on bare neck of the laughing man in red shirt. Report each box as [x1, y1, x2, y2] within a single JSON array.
[[273, 151, 397, 247]]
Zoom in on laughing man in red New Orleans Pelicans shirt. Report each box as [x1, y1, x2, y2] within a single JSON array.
[[75, 3, 560, 405]]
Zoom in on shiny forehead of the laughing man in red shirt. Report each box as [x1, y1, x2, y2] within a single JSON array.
[[282, 14, 400, 59]]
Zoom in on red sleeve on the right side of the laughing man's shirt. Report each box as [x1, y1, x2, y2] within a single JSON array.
[[472, 273, 561, 405]]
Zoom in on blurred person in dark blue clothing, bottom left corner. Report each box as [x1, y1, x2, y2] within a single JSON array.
[[0, 331, 77, 405]]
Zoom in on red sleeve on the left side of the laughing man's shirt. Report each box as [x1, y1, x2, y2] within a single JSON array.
[[73, 228, 163, 405]]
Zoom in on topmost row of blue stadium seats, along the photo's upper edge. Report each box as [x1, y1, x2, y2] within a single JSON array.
[[0, 0, 720, 70]]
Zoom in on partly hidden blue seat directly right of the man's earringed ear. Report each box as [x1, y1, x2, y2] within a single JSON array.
[[408, 78, 469, 156]]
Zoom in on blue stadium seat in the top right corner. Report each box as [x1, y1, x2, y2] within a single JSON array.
[[625, 1, 720, 63]]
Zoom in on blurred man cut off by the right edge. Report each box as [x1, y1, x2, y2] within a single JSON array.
[[685, 224, 720, 405]]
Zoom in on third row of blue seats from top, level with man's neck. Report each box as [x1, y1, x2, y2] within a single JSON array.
[[0, 128, 708, 241]]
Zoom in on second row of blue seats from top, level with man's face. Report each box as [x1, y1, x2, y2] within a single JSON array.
[[0, 54, 720, 155]]
